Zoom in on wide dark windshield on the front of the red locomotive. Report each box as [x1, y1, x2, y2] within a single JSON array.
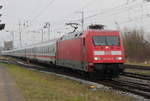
[[93, 36, 120, 46]]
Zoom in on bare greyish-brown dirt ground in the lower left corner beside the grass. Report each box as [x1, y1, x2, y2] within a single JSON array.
[[0, 65, 25, 101]]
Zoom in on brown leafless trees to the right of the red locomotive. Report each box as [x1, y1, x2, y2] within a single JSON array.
[[123, 28, 150, 62]]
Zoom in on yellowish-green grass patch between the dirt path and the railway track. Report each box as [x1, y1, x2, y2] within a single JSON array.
[[1, 64, 137, 101]]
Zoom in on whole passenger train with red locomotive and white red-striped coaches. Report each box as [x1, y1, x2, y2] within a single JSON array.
[[2, 24, 125, 78]]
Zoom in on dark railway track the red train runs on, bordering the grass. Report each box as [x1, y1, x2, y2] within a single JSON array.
[[0, 58, 150, 99]]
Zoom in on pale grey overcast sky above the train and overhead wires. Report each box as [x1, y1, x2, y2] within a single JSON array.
[[0, 0, 150, 47]]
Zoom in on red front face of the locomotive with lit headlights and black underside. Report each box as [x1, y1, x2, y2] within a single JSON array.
[[85, 30, 125, 76]]
